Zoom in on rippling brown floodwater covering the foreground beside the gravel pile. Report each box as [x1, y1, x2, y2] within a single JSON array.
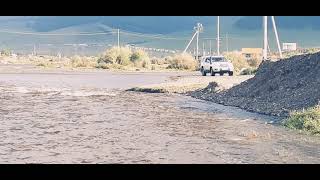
[[0, 67, 320, 163]]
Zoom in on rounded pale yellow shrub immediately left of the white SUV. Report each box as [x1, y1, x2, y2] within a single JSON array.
[[168, 53, 198, 71]]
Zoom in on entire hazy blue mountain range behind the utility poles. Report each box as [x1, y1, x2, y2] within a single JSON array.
[[0, 16, 320, 54]]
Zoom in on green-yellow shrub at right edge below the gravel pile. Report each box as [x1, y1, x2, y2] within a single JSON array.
[[284, 105, 320, 135]]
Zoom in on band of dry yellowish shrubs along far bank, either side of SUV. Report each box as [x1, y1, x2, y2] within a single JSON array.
[[1, 46, 261, 74]]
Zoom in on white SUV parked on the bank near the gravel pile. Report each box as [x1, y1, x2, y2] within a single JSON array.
[[200, 56, 233, 76]]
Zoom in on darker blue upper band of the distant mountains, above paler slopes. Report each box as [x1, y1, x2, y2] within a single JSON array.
[[0, 16, 320, 34]]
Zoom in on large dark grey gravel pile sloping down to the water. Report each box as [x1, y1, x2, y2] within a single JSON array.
[[190, 53, 320, 117]]
